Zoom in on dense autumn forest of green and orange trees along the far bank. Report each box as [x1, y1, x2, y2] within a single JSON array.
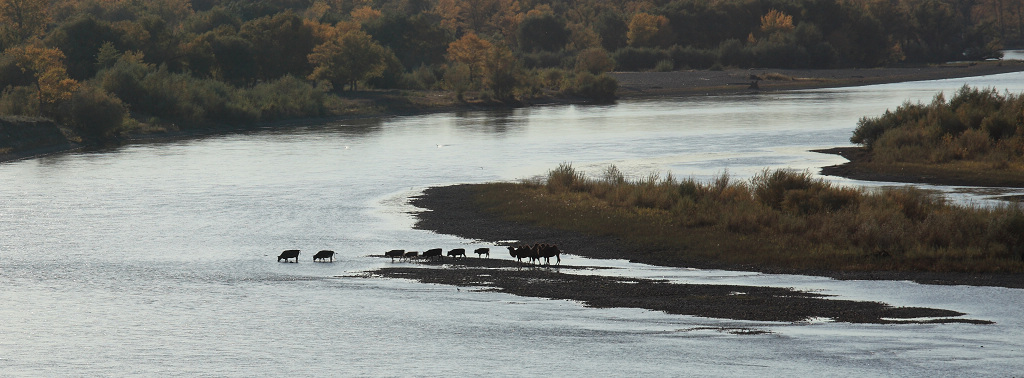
[[0, 0, 1024, 138]]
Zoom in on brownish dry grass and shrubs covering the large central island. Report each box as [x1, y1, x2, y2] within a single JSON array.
[[481, 164, 1024, 272]]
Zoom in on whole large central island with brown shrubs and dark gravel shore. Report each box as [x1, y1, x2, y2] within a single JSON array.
[[413, 165, 1024, 288]]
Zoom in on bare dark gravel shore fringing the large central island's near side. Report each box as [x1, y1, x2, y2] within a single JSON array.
[[411, 184, 1024, 288]]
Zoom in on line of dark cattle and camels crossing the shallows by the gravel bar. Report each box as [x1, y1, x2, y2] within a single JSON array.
[[278, 244, 562, 264]]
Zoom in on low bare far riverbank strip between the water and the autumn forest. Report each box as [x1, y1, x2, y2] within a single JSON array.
[[8, 60, 1024, 162]]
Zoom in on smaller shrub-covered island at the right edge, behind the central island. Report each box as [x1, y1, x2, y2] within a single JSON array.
[[824, 86, 1024, 187]]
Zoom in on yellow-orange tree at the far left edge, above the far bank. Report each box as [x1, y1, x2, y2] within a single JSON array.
[[4, 44, 79, 113]]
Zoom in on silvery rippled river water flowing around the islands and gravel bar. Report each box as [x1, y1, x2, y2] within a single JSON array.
[[0, 74, 1024, 376]]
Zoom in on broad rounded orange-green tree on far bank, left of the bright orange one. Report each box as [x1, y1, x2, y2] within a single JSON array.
[[308, 30, 397, 90]]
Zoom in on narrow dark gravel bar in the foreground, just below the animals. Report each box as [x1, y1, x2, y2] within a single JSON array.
[[369, 258, 992, 324]]
